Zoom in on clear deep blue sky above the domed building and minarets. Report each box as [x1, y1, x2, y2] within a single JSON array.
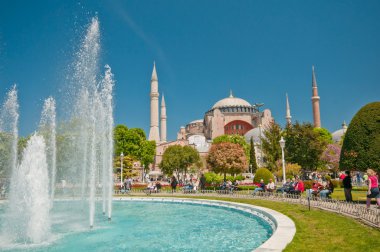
[[0, 0, 380, 139]]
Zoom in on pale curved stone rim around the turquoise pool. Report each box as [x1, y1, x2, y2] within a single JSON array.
[[113, 197, 296, 252]]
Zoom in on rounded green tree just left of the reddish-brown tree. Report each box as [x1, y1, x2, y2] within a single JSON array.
[[159, 145, 200, 177]]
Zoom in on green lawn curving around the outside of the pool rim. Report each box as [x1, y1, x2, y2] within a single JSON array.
[[144, 195, 380, 252]]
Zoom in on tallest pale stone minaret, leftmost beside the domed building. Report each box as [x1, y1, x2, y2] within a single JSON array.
[[149, 63, 160, 144]]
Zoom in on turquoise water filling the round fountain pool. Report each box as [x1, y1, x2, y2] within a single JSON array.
[[0, 201, 273, 251]]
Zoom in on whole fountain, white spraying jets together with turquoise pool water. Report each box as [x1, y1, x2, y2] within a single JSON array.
[[0, 15, 288, 251]]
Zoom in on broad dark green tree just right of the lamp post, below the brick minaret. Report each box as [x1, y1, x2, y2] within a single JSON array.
[[285, 122, 326, 170]]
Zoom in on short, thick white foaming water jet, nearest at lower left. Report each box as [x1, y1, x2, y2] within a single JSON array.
[[5, 134, 50, 243]]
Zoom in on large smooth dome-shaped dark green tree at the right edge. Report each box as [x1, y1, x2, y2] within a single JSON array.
[[339, 102, 380, 172]]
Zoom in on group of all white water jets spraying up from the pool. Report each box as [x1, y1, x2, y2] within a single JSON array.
[[0, 15, 114, 244]]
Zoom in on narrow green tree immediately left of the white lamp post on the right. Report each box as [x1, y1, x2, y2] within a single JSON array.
[[261, 122, 281, 171]]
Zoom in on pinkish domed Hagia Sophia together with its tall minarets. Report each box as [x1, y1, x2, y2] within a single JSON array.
[[145, 63, 347, 175]]
